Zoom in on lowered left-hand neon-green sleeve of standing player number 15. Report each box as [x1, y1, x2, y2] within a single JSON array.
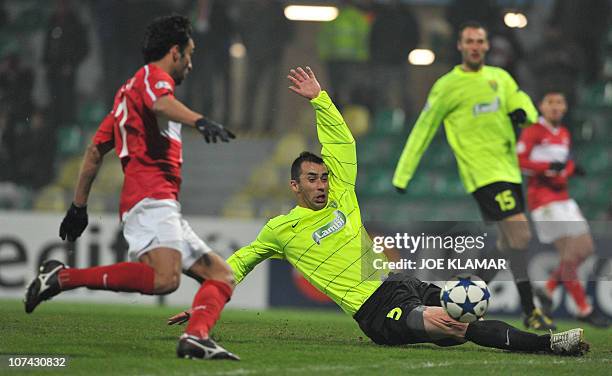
[[393, 81, 449, 192]]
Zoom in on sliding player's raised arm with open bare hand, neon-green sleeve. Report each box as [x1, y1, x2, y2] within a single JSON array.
[[287, 67, 357, 189]]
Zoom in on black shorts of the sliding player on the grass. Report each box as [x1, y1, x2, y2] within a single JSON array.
[[353, 274, 457, 346]]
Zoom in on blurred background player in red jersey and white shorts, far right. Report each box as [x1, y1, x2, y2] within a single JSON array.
[[517, 91, 609, 327]]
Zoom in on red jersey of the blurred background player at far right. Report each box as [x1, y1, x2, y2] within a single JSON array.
[[516, 118, 575, 210]]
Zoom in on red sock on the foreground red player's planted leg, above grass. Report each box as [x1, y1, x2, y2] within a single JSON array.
[[185, 280, 232, 338]]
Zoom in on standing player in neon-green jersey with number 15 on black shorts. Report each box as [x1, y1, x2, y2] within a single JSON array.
[[393, 22, 555, 330]]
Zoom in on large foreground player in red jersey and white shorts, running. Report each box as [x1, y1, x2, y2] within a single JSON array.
[[25, 15, 238, 360]]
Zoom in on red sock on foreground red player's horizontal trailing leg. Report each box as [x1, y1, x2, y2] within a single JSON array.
[[59, 262, 155, 295]]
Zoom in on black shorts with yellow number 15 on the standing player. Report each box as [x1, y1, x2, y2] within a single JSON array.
[[472, 181, 525, 221]]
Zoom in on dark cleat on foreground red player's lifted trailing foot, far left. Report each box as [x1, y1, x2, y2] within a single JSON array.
[[23, 260, 66, 313]]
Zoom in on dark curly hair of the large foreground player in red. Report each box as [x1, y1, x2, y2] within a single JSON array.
[[142, 14, 192, 64]]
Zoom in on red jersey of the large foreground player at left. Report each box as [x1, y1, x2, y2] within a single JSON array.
[[93, 64, 183, 215]]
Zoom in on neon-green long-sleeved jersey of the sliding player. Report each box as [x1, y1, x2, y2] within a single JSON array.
[[227, 91, 383, 315]]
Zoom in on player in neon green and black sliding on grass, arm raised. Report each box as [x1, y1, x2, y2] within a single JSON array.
[[168, 67, 588, 355]]
